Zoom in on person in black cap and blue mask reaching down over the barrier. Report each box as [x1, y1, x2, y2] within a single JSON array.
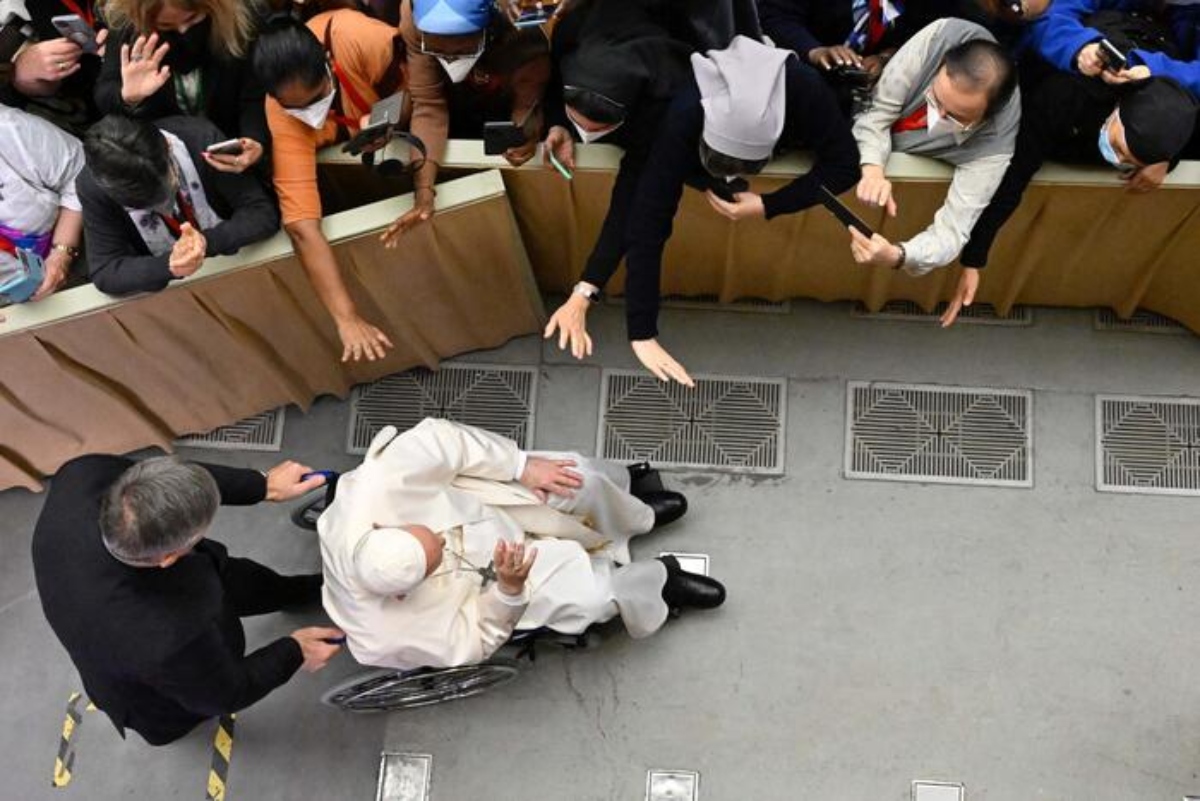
[[961, 73, 1198, 297]]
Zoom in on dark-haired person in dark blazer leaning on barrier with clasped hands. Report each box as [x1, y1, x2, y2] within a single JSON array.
[[77, 114, 280, 295]]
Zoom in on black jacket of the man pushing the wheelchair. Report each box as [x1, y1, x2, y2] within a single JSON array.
[[34, 456, 304, 745]]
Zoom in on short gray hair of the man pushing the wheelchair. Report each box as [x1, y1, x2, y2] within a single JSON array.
[[100, 456, 221, 566]]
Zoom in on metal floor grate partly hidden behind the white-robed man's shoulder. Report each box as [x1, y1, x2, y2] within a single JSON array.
[[346, 365, 538, 453]]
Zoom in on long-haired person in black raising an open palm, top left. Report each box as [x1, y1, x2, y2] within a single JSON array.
[[96, 0, 270, 174]]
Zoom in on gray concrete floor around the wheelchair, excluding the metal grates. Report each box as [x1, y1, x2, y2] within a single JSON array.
[[7, 303, 1200, 801]]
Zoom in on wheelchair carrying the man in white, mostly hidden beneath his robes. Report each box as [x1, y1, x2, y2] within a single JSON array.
[[292, 470, 600, 712]]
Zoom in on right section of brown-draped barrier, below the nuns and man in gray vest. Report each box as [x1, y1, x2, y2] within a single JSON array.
[[323, 141, 1200, 331]]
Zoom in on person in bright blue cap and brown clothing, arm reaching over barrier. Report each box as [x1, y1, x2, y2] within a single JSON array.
[[385, 0, 550, 245]]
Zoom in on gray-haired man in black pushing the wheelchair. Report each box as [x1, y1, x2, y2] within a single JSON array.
[[32, 456, 342, 745]]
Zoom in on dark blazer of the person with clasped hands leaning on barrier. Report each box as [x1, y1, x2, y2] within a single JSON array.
[[76, 116, 280, 295]]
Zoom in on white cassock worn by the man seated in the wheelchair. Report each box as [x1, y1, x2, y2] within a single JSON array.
[[317, 418, 667, 669]]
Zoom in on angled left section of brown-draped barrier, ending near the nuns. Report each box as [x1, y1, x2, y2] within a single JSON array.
[[0, 170, 545, 489]]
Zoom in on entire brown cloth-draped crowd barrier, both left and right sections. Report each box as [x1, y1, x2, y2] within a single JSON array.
[[0, 141, 1200, 488]]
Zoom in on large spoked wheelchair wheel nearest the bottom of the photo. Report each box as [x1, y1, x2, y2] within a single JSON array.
[[320, 658, 520, 712]]
